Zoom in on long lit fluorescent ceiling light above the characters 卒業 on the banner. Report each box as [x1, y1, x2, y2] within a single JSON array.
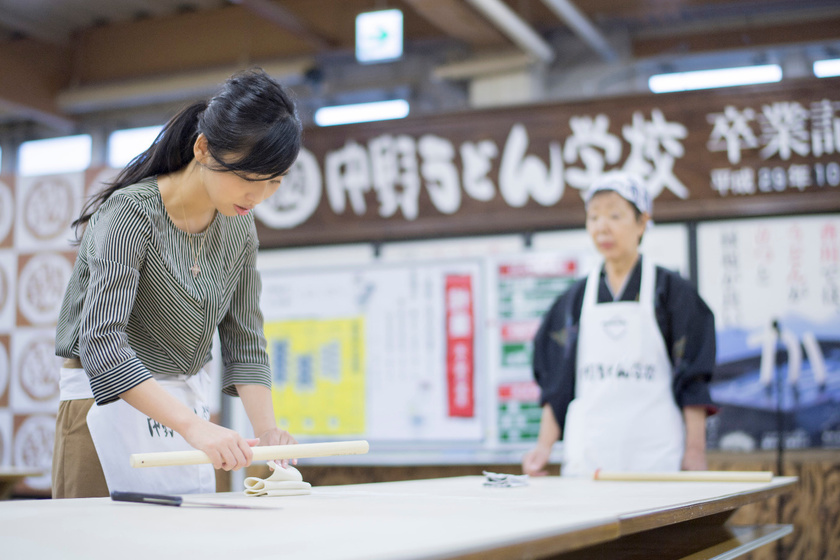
[[648, 64, 782, 93]]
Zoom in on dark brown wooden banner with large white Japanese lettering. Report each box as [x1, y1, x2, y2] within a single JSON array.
[[257, 79, 840, 248]]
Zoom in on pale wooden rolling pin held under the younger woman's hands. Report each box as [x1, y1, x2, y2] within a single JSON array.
[[129, 440, 370, 467]]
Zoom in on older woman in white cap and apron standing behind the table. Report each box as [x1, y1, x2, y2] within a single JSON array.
[[522, 172, 715, 476]]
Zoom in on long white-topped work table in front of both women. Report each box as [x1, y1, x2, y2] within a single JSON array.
[[0, 476, 796, 560]]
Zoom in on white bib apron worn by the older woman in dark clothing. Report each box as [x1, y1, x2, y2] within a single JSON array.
[[562, 259, 685, 476]]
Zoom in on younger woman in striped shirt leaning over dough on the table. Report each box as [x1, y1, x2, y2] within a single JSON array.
[[52, 70, 301, 498]]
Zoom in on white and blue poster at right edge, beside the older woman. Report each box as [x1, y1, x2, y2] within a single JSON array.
[[697, 214, 840, 451]]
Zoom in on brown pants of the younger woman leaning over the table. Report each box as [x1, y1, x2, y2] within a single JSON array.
[[52, 399, 109, 498]]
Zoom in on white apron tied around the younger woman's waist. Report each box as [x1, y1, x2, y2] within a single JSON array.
[[87, 369, 216, 494]]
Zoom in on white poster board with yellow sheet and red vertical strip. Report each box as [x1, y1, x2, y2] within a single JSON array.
[[262, 261, 483, 442]]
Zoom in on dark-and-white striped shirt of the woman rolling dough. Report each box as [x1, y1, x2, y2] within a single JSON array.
[[56, 177, 271, 404]]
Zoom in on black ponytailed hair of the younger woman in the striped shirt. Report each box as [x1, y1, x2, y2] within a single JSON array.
[[72, 68, 302, 239]]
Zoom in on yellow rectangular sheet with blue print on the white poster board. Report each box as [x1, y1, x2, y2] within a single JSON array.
[[265, 317, 366, 436]]
